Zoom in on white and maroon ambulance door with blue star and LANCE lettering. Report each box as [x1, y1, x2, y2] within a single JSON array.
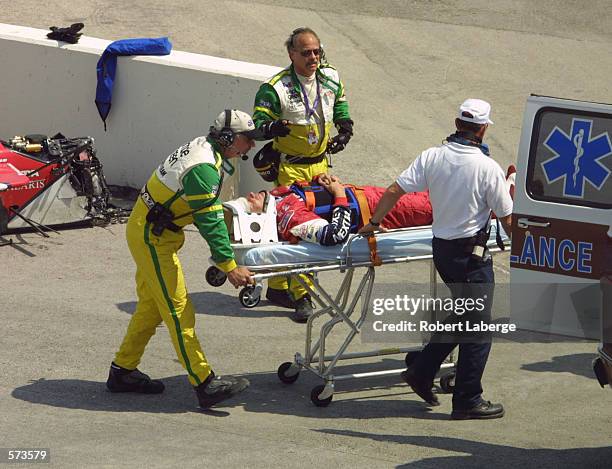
[[510, 95, 612, 387]]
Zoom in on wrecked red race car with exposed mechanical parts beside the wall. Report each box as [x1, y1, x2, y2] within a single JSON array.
[[0, 134, 124, 234]]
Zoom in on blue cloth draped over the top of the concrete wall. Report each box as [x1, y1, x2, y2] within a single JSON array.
[[96, 37, 172, 130]]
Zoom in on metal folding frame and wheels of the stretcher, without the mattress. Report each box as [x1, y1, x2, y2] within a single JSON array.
[[227, 226, 510, 407]]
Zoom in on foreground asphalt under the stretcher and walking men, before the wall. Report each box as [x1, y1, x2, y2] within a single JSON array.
[[0, 224, 612, 468]]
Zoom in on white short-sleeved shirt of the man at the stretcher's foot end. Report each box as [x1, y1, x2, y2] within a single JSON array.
[[397, 143, 512, 239]]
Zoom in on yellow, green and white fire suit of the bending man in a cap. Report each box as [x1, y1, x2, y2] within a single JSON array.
[[114, 137, 236, 386]]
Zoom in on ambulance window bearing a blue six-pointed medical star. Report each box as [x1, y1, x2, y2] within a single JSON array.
[[527, 108, 612, 208]]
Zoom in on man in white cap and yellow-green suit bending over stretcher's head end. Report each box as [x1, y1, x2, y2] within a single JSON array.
[[106, 110, 259, 409]]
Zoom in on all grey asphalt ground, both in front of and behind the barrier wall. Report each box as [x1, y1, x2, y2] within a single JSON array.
[[0, 0, 612, 468]]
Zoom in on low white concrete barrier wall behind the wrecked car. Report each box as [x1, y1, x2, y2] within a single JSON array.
[[0, 23, 279, 197]]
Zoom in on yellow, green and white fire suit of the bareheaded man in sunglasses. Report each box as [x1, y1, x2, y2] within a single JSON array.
[[253, 64, 350, 299]]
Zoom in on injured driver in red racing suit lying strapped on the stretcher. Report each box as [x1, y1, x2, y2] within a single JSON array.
[[239, 174, 432, 246]]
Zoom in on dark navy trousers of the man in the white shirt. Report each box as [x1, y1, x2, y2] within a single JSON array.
[[413, 238, 495, 410]]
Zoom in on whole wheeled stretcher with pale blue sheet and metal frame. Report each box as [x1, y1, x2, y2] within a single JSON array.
[[206, 202, 510, 407]]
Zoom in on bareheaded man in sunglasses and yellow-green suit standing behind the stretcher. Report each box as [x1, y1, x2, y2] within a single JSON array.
[[253, 28, 353, 322]]
